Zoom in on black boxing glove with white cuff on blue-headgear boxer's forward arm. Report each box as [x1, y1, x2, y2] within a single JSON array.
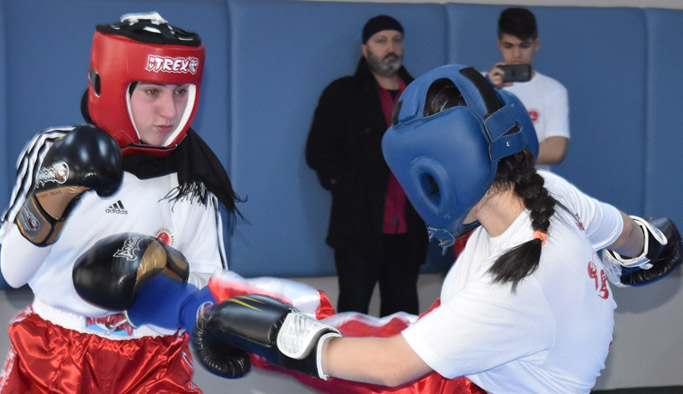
[[193, 295, 341, 379]]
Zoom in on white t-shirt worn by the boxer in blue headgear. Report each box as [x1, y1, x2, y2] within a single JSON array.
[[403, 171, 623, 393]]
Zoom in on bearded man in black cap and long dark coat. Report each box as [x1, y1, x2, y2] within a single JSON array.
[[306, 15, 428, 316]]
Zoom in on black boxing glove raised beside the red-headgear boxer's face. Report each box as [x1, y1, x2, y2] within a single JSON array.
[[15, 125, 123, 246]]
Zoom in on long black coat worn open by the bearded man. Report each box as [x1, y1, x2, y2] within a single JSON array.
[[306, 57, 428, 263]]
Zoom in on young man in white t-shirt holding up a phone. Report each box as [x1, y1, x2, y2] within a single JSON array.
[[487, 8, 569, 169]]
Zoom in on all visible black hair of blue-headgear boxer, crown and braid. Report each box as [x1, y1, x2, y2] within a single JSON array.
[[424, 79, 561, 292]]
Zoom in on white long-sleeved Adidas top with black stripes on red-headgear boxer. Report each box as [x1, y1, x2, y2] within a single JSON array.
[[0, 129, 225, 333]]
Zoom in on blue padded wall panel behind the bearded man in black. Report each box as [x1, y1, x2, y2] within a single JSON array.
[[230, 1, 446, 276]]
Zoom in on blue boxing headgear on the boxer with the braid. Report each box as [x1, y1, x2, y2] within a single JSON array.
[[382, 65, 538, 247]]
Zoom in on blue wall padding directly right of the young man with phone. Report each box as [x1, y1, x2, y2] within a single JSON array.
[[533, 7, 647, 215]]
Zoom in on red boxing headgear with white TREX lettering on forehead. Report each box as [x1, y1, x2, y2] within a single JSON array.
[[88, 12, 204, 156]]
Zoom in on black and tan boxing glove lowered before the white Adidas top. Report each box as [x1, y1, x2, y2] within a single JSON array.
[[72, 233, 190, 311]]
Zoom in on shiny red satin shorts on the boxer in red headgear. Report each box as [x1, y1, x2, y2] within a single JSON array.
[[0, 307, 201, 394]]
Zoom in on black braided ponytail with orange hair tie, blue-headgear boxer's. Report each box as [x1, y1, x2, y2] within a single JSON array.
[[489, 149, 557, 292]]
